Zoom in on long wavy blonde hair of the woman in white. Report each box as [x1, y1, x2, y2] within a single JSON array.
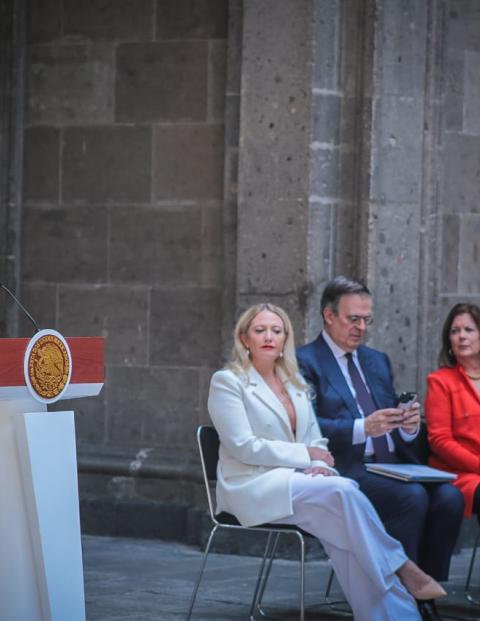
[[227, 302, 307, 390]]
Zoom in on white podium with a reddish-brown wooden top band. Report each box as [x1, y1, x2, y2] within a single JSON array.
[[0, 337, 104, 621]]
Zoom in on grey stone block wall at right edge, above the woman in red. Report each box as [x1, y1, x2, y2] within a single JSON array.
[[438, 0, 480, 319]]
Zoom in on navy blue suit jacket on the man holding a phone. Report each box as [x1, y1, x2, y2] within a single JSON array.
[[297, 334, 419, 478]]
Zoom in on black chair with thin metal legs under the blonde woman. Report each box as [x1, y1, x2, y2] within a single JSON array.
[[186, 426, 349, 621]]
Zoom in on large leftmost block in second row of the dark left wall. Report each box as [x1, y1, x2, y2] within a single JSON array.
[[28, 45, 114, 125]]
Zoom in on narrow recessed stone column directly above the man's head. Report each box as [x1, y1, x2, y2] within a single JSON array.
[[306, 0, 374, 340]]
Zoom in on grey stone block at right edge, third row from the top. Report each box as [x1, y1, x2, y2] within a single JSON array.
[[442, 133, 480, 213]]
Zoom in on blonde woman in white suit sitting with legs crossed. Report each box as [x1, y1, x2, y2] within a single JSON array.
[[208, 304, 445, 621]]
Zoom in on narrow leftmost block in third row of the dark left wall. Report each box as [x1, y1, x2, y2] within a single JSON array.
[[23, 127, 60, 205]]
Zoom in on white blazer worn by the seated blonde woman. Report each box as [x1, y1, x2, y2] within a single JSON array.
[[208, 367, 336, 526]]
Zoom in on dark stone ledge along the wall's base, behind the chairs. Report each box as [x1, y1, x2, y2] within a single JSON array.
[[78, 446, 478, 558]]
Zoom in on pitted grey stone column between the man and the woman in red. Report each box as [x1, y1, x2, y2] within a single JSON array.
[[358, 0, 429, 390]]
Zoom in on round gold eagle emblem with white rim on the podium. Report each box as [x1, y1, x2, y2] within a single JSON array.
[[24, 330, 72, 403]]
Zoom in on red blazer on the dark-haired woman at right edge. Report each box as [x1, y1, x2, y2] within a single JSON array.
[[425, 365, 480, 517]]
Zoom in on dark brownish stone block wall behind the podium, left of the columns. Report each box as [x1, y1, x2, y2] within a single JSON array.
[[21, 0, 228, 464]]
